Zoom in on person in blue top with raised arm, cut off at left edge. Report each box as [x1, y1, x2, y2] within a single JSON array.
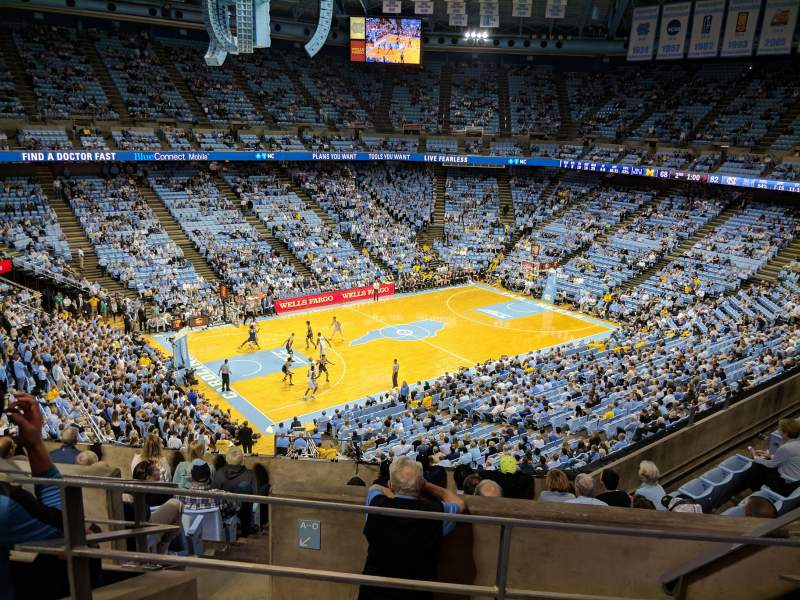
[[0, 393, 63, 598]]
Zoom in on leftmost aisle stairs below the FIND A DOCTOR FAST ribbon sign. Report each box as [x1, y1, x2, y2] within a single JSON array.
[[35, 165, 138, 298]]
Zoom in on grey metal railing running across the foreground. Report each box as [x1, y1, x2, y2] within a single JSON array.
[[3, 471, 800, 600]]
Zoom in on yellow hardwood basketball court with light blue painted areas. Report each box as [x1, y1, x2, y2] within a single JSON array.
[[159, 285, 614, 440]]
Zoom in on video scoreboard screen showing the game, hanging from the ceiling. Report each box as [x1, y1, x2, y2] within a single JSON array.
[[350, 17, 422, 65]]
